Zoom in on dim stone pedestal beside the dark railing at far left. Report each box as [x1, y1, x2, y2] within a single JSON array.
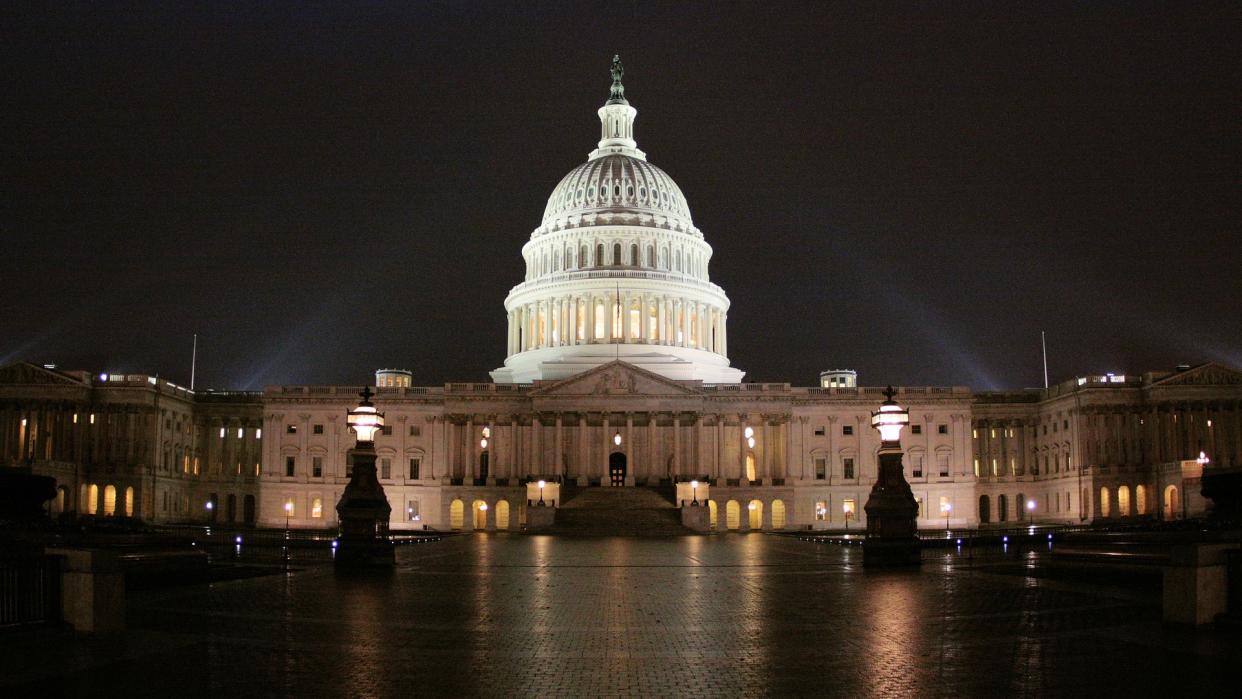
[[47, 548, 125, 633]]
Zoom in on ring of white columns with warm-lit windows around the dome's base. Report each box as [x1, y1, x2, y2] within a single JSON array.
[[507, 291, 728, 356]]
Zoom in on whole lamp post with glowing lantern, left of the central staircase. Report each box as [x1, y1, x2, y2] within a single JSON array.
[[335, 386, 394, 567]]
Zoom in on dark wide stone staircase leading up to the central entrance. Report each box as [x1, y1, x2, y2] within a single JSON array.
[[548, 487, 694, 536]]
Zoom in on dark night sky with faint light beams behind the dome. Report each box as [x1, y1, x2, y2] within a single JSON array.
[[0, 1, 1242, 390]]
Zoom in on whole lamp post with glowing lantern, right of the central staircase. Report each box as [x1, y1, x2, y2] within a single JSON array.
[[862, 386, 920, 566]]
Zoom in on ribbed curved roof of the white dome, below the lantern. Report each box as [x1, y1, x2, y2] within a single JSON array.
[[543, 154, 694, 228]]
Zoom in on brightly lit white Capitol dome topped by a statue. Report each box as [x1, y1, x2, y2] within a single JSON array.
[[492, 58, 743, 384]]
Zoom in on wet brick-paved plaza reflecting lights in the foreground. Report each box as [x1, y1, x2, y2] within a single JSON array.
[[0, 534, 1242, 697]]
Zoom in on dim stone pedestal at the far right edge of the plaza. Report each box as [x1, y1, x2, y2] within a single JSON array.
[[1164, 544, 1238, 626]]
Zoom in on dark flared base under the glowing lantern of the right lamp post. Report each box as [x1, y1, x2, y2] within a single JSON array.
[[862, 442, 920, 567]]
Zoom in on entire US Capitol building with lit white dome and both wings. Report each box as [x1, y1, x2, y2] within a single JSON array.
[[0, 61, 1242, 530]]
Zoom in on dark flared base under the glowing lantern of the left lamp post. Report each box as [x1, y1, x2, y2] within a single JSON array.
[[337, 442, 394, 567]]
